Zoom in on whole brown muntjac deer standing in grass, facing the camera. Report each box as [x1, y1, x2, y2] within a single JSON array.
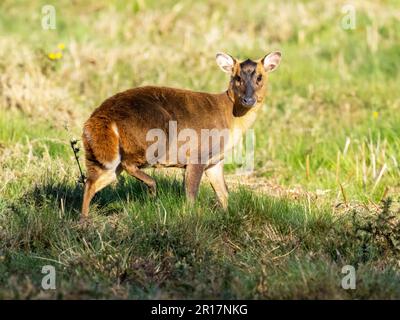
[[81, 52, 281, 218]]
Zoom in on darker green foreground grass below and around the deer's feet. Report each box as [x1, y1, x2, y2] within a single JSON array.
[[0, 173, 399, 299]]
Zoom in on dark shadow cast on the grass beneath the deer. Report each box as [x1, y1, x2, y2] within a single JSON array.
[[20, 176, 184, 215]]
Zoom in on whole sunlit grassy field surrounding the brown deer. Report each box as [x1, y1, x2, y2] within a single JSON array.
[[0, 0, 400, 299]]
